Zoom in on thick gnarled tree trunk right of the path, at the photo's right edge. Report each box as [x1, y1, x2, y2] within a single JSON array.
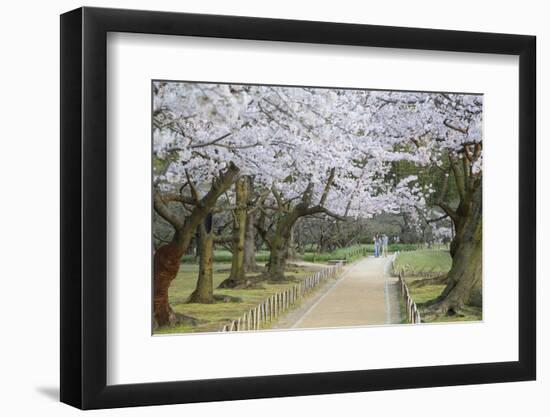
[[432, 186, 483, 314]]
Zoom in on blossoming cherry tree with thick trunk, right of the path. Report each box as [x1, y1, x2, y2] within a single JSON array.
[[372, 92, 483, 314]]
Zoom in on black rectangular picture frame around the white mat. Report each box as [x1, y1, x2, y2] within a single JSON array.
[[60, 7, 536, 409]]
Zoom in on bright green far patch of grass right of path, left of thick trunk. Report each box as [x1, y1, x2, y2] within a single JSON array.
[[395, 249, 452, 276]]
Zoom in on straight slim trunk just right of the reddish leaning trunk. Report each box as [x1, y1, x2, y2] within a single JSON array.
[[189, 214, 214, 304]]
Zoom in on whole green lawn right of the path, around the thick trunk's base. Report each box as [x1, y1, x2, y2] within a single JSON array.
[[395, 250, 482, 323]]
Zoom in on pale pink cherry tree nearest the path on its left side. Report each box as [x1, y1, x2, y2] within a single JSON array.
[[245, 87, 426, 280]]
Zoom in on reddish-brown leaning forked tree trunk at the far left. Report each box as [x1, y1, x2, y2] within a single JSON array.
[[153, 164, 239, 327]]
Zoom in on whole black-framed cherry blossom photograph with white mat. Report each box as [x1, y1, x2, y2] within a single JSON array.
[[60, 7, 536, 409]]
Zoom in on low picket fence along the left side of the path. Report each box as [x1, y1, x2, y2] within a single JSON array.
[[220, 262, 343, 332]]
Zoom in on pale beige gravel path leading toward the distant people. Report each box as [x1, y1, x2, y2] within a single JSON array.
[[292, 257, 400, 328]]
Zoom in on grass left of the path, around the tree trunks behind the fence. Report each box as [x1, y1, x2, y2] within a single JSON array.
[[155, 263, 322, 334]]
